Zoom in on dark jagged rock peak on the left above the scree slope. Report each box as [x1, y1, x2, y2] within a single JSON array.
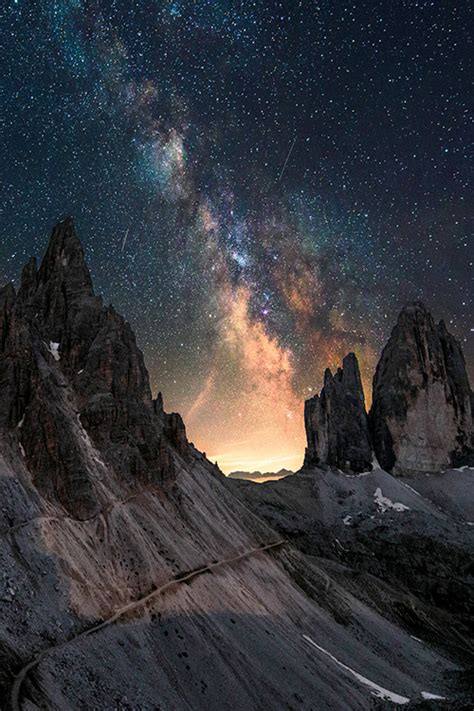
[[0, 219, 187, 518]]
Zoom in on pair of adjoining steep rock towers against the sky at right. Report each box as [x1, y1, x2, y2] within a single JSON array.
[[305, 302, 474, 475]]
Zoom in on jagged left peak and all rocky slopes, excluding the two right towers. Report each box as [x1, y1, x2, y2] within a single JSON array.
[[0, 220, 473, 711]]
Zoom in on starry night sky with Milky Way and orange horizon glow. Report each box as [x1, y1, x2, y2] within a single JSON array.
[[0, 0, 474, 472]]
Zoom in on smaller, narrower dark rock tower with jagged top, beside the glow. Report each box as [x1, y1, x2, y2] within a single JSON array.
[[305, 353, 372, 472]]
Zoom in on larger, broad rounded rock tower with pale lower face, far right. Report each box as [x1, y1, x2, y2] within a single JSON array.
[[370, 302, 473, 474]]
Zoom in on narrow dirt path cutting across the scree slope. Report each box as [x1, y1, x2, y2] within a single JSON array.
[[10, 540, 286, 711]]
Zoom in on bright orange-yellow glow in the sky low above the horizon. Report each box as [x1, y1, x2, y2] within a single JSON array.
[[185, 285, 305, 474]]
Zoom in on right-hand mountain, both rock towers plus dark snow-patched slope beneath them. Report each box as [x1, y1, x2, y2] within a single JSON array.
[[232, 310, 474, 707]]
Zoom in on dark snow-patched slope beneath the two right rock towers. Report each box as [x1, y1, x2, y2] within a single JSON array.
[[232, 467, 474, 648]]
